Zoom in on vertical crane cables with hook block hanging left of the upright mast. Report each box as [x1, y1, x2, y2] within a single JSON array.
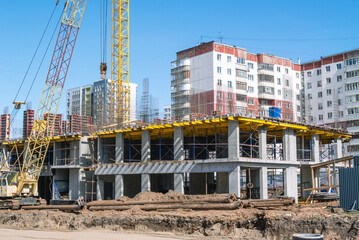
[[100, 0, 108, 79]]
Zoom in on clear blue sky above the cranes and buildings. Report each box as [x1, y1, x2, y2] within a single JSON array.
[[0, 0, 359, 137]]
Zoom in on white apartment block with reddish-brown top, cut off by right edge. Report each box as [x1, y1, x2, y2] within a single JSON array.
[[301, 50, 359, 157]]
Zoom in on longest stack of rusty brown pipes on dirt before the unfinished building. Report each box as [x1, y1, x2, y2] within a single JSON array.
[[87, 194, 241, 211]]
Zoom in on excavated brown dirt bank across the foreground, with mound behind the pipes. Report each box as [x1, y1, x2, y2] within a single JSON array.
[[0, 193, 359, 240]]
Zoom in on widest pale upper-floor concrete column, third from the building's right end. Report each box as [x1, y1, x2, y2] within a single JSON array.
[[283, 128, 297, 162]]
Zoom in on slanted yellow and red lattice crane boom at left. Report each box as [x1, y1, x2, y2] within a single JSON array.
[[17, 0, 87, 195]]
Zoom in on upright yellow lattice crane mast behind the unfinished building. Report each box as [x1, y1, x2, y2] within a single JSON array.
[[111, 0, 130, 125]]
